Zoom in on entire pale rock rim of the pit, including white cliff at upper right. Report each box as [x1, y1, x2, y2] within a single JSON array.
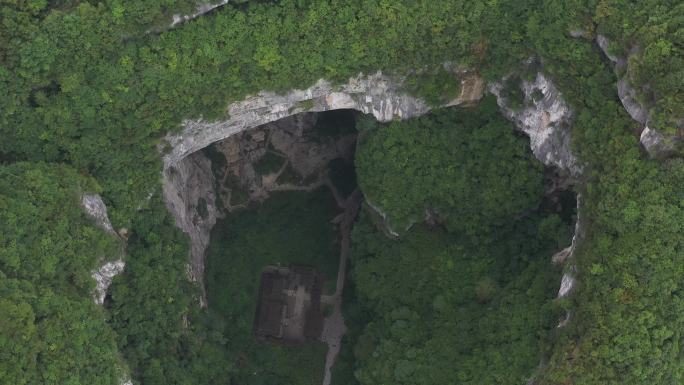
[[163, 72, 581, 303]]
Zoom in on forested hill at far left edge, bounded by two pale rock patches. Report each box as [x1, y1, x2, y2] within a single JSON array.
[[0, 162, 126, 385]]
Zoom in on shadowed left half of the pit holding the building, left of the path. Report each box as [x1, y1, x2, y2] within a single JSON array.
[[198, 110, 361, 384]]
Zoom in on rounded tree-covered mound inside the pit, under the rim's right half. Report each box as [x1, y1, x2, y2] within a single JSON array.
[[356, 97, 543, 232]]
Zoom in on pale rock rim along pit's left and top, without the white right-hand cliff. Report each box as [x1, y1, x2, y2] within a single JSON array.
[[163, 72, 484, 290]]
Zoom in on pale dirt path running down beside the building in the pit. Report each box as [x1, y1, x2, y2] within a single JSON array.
[[321, 187, 363, 385]]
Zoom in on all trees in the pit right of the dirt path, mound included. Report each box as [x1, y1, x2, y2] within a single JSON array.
[[352, 99, 574, 384]]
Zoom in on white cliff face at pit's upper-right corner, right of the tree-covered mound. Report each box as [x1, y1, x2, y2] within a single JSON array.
[[489, 73, 582, 176]]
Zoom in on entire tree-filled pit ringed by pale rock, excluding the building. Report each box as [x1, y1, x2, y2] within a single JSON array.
[[196, 101, 576, 384]]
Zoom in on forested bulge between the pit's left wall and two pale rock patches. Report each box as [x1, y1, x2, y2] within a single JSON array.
[[105, 197, 232, 385]]
